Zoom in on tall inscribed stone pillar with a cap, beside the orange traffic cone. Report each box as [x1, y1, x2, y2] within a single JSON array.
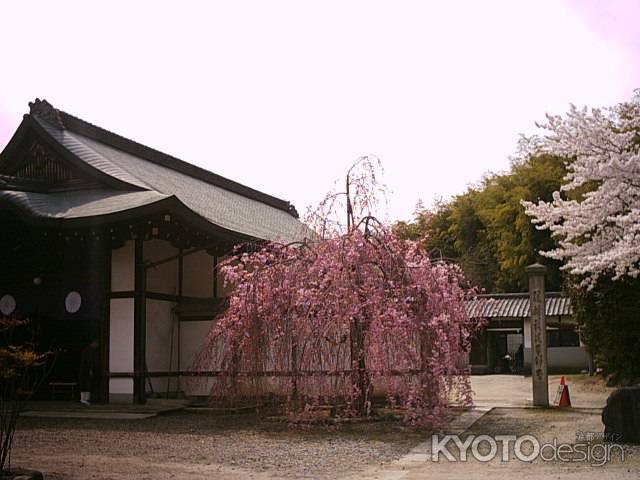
[[525, 263, 549, 407]]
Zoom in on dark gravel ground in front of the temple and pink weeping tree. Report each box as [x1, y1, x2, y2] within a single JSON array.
[[12, 411, 427, 479]]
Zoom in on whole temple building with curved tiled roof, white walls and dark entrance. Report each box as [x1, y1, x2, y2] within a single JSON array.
[[0, 99, 311, 403]]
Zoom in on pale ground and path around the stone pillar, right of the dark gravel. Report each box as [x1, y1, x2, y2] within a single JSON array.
[[351, 375, 640, 480]]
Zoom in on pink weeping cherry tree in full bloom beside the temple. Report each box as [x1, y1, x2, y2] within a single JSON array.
[[197, 157, 480, 427]]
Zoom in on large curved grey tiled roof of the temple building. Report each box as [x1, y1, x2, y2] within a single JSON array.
[[0, 100, 313, 242]]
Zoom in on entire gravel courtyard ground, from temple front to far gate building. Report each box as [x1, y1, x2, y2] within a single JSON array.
[[13, 375, 640, 480]]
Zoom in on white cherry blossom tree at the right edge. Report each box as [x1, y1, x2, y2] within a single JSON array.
[[523, 90, 640, 287]]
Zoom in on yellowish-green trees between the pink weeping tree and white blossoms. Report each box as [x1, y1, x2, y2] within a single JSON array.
[[396, 155, 566, 292]]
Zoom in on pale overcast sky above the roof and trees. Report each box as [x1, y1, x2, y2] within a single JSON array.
[[0, 0, 640, 219]]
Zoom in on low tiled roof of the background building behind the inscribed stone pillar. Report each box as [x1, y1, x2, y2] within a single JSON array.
[[466, 292, 573, 318]]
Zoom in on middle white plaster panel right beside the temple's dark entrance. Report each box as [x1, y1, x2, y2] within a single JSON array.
[[109, 298, 133, 374]]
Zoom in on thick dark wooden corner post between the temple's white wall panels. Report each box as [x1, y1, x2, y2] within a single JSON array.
[[133, 238, 147, 404]]
